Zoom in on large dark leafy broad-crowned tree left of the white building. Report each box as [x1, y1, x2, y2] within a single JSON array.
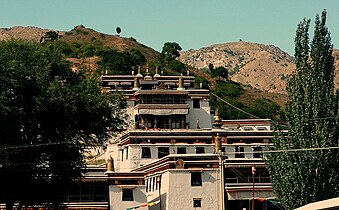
[[0, 41, 124, 209]]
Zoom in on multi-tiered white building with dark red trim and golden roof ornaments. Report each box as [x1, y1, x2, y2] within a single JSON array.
[[62, 68, 286, 210]]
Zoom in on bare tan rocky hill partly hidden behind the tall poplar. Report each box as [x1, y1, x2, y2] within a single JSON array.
[[180, 41, 339, 93]]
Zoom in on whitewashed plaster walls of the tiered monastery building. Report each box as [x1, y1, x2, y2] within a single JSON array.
[[96, 74, 284, 210]]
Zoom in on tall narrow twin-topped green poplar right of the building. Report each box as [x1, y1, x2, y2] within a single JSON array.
[[267, 10, 339, 209]]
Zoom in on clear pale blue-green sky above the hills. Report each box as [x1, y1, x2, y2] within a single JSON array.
[[0, 0, 339, 55]]
